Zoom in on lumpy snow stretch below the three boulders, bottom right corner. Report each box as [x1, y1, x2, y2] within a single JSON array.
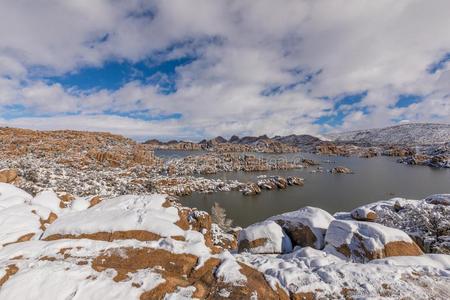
[[237, 250, 450, 299]]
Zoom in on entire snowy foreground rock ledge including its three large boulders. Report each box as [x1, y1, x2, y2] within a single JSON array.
[[0, 183, 450, 300]]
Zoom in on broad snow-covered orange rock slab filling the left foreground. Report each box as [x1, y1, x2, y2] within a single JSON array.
[[0, 185, 286, 300]]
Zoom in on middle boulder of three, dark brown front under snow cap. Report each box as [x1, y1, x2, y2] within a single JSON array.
[[269, 206, 334, 249]]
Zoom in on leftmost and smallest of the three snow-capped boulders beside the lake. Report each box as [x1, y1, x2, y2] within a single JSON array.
[[238, 220, 292, 254]]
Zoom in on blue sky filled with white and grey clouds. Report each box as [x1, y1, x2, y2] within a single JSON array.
[[0, 0, 450, 140]]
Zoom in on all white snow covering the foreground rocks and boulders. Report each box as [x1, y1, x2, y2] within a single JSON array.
[[0, 184, 450, 300]]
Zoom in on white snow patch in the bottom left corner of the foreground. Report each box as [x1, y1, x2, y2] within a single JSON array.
[[0, 261, 164, 300]]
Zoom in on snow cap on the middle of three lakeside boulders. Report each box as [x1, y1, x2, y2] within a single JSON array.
[[268, 206, 334, 249]]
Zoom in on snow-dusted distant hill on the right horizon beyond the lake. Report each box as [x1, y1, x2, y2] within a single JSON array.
[[328, 123, 450, 146]]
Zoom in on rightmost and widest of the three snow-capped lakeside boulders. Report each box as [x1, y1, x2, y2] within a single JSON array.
[[325, 220, 423, 262]]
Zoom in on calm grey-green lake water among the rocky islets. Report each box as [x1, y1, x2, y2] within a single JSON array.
[[156, 151, 450, 226]]
